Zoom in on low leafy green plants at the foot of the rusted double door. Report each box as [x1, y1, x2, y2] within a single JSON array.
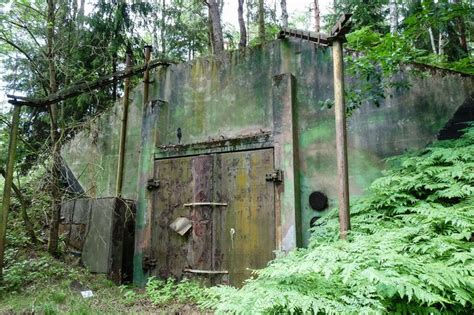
[[146, 277, 208, 305]]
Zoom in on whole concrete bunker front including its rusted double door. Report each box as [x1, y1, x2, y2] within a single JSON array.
[[62, 40, 473, 285]]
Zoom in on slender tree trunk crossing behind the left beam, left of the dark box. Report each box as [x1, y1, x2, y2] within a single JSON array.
[[46, 0, 61, 255]]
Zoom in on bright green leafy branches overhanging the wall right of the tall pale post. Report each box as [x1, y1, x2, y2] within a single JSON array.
[[342, 27, 474, 114]]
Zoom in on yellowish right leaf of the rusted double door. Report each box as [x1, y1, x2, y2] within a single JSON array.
[[214, 149, 275, 286]]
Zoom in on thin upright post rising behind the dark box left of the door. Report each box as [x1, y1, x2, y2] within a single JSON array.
[[115, 53, 132, 197]]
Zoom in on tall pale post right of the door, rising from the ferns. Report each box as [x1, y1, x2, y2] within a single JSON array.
[[332, 38, 351, 239]]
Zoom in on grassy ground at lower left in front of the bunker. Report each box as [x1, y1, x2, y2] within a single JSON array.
[[0, 251, 203, 314]]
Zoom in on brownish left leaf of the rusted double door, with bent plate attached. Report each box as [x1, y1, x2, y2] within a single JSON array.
[[151, 156, 212, 278]]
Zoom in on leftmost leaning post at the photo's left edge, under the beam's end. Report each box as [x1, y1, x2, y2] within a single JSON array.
[[0, 105, 21, 282]]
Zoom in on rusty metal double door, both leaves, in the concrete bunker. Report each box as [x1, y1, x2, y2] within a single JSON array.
[[150, 149, 276, 286]]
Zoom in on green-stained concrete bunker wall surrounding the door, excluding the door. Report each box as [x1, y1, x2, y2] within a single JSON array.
[[63, 40, 473, 286]]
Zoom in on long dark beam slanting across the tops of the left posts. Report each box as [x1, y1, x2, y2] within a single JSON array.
[[7, 60, 172, 107]]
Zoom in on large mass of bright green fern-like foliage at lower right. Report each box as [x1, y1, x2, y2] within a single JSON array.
[[208, 127, 474, 314]]
